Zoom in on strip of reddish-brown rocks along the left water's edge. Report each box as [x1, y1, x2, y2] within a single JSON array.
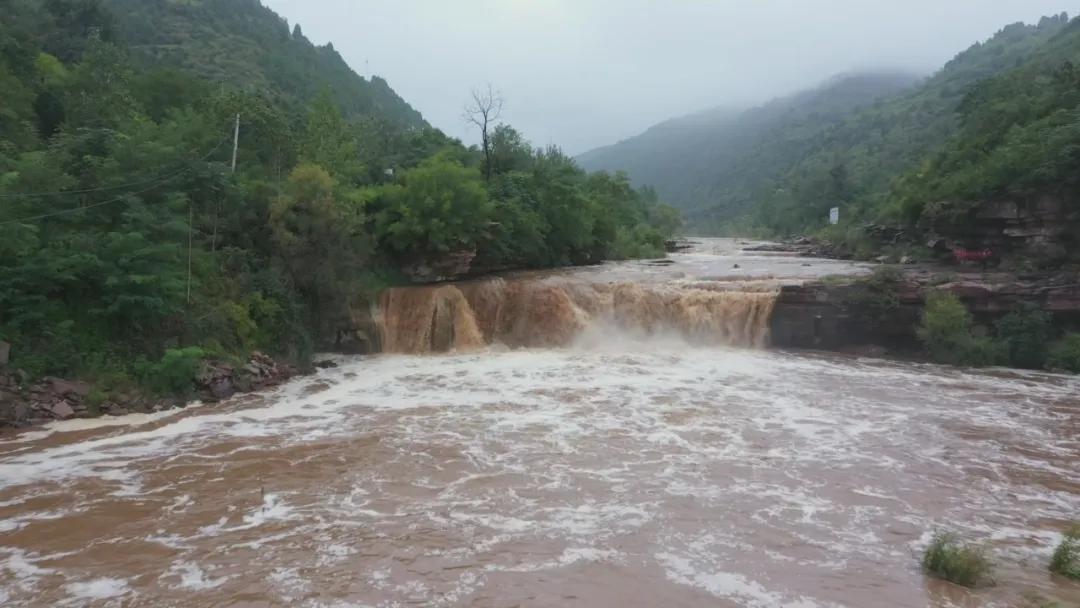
[[0, 353, 299, 429]]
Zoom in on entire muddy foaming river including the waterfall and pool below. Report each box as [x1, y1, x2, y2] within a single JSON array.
[[0, 242, 1080, 608]]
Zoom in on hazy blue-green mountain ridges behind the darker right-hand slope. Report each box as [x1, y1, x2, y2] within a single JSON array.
[[578, 14, 1068, 232]]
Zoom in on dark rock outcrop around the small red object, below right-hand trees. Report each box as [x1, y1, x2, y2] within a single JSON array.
[[920, 194, 1080, 266]]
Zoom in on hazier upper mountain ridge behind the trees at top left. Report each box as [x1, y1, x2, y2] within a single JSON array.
[[104, 0, 428, 129]]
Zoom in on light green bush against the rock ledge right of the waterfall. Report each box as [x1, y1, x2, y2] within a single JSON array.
[[918, 292, 1004, 366]]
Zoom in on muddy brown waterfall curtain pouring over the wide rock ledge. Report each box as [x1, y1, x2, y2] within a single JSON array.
[[378, 278, 777, 354]]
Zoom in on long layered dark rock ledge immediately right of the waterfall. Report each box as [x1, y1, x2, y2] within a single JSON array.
[[771, 271, 1080, 352]]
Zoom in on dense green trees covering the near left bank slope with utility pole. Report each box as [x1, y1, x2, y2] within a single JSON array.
[[0, 0, 678, 418]]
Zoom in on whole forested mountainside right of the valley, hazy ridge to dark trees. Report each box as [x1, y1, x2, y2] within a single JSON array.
[[580, 14, 1080, 242]]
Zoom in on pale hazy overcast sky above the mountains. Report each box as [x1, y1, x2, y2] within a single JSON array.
[[264, 0, 1080, 153]]
